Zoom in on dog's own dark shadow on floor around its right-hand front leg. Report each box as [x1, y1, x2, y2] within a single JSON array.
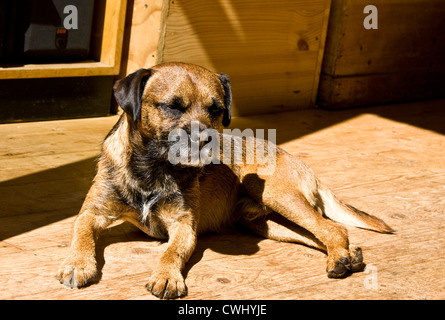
[[93, 222, 264, 285]]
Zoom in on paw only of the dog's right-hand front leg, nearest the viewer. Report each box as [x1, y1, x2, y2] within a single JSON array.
[[145, 270, 187, 299]]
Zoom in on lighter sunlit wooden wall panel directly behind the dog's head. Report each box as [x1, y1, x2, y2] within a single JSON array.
[[121, 0, 330, 115]]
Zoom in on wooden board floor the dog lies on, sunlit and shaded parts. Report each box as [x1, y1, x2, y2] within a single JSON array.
[[0, 101, 445, 299]]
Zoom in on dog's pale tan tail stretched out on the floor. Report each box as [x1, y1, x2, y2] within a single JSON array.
[[316, 184, 395, 233]]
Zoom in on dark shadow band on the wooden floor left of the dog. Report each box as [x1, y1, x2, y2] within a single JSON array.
[[0, 158, 96, 240]]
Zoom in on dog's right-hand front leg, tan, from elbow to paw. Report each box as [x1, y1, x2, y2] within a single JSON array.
[[146, 212, 197, 299]]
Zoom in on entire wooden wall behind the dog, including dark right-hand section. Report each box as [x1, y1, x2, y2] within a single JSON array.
[[120, 0, 445, 115]]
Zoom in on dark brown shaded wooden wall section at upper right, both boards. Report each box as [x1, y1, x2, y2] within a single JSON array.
[[318, 0, 445, 108]]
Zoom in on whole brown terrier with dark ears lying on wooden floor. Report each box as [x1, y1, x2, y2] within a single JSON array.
[[57, 63, 392, 298]]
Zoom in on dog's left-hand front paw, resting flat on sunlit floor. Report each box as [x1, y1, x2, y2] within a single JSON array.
[[56, 257, 98, 289]]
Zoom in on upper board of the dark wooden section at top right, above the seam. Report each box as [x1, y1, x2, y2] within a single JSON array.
[[323, 0, 445, 76]]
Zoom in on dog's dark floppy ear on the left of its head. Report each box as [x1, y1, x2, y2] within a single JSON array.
[[113, 69, 151, 122]]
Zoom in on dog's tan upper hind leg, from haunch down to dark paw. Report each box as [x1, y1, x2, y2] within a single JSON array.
[[220, 135, 364, 278]]
